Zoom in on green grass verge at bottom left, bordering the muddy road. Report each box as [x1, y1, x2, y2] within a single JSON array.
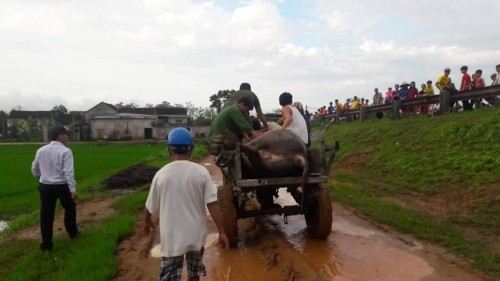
[[0, 191, 147, 281]]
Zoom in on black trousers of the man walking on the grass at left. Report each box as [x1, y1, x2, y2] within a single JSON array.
[[38, 183, 78, 250]]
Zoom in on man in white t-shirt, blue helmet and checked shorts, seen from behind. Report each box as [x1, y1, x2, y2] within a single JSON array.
[[144, 128, 229, 281]]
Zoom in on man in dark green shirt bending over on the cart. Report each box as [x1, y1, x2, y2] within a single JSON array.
[[208, 96, 261, 155]]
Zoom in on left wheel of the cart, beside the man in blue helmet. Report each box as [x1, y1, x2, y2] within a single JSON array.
[[217, 184, 238, 247]]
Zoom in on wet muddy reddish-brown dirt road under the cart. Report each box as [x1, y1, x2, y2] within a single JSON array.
[[114, 155, 488, 281]]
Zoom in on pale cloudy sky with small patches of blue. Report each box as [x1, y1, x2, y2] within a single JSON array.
[[0, 0, 500, 112]]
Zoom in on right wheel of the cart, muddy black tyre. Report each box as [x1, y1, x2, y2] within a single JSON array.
[[304, 183, 332, 239]]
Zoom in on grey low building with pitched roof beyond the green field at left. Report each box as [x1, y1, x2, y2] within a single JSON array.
[[85, 102, 188, 140]]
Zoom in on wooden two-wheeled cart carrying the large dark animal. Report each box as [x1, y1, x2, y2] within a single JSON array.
[[216, 142, 339, 246]]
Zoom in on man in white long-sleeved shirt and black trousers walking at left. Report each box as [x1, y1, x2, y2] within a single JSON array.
[[31, 125, 80, 251]]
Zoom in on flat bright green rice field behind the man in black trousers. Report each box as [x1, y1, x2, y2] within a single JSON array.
[[0, 143, 167, 220]]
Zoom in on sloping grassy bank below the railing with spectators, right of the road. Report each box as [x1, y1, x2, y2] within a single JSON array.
[[323, 108, 500, 278]]
